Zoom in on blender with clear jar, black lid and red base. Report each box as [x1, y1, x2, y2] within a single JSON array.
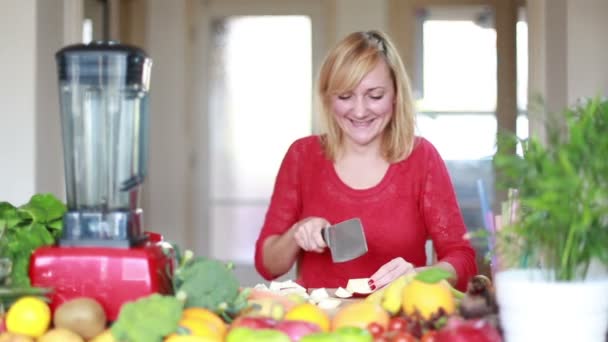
[[29, 41, 173, 320]]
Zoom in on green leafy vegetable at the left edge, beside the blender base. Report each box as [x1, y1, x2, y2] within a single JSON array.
[[0, 194, 67, 287]]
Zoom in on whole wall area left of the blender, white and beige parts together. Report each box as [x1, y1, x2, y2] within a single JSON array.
[[0, 0, 82, 205]]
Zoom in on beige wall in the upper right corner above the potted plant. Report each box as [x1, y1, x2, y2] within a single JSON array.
[[528, 0, 608, 138]]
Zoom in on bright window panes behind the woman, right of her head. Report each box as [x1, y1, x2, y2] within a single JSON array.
[[414, 6, 528, 250]]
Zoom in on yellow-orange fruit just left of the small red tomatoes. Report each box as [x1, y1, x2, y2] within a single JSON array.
[[332, 301, 390, 330]]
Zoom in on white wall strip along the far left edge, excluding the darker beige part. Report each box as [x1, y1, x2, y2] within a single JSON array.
[[0, 0, 37, 204]]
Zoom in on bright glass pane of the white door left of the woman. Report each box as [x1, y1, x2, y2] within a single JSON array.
[[209, 15, 312, 264]]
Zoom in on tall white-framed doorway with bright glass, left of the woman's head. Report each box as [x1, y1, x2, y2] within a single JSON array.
[[193, 0, 325, 286]]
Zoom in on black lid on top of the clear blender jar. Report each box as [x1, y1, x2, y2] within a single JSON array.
[[55, 40, 152, 89]]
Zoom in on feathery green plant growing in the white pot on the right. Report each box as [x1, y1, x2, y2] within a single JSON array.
[[495, 98, 608, 281]]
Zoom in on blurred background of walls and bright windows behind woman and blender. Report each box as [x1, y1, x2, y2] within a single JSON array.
[[0, 0, 608, 284]]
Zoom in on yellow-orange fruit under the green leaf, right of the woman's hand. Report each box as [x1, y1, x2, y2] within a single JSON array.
[[402, 279, 456, 319]]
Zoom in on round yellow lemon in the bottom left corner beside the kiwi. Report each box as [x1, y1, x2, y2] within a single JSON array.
[[6, 296, 51, 337]]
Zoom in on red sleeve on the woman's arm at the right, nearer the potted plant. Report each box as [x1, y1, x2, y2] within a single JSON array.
[[420, 144, 477, 291]]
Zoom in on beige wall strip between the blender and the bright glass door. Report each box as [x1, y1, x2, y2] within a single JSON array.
[[143, 0, 193, 248]]
